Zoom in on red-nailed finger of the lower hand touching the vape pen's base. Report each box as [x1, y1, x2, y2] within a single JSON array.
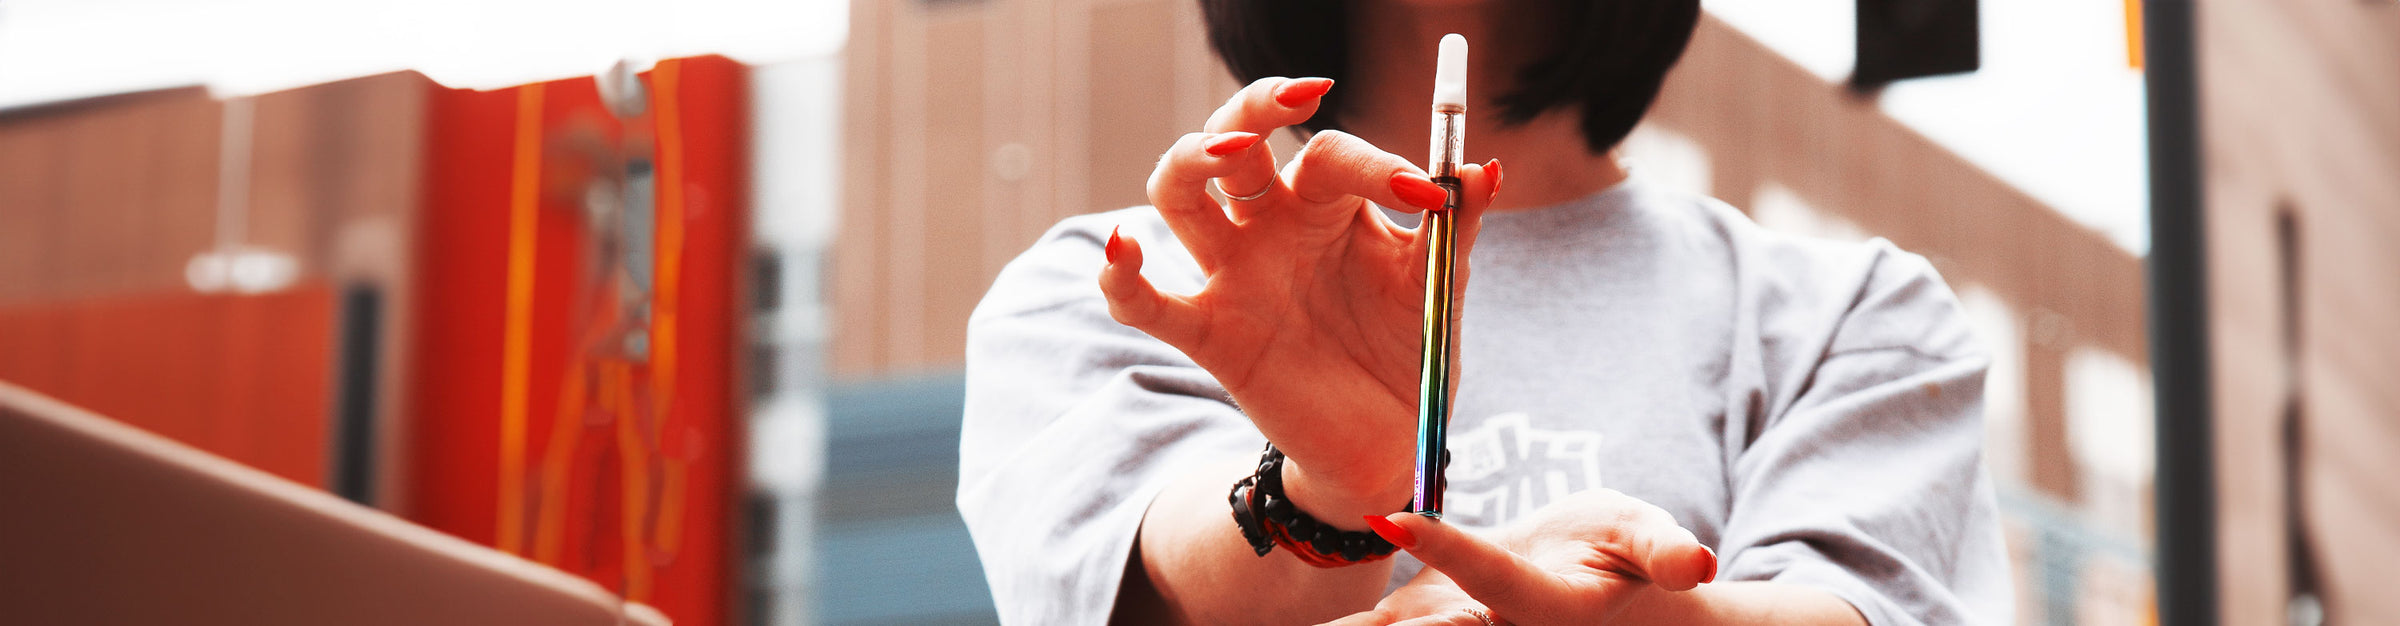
[[1366, 511, 1558, 614]]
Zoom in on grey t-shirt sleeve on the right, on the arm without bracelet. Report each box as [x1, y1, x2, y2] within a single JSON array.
[[1721, 242, 2014, 626]]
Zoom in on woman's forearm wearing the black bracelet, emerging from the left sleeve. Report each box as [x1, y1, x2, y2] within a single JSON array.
[[1116, 456, 1392, 624]]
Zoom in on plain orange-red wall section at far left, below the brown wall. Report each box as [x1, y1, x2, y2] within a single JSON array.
[[0, 285, 334, 487]]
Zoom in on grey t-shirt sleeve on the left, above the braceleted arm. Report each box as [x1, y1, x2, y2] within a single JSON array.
[[958, 209, 1265, 624]]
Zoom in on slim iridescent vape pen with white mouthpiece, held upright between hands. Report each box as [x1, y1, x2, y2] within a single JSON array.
[[1409, 34, 1466, 518]]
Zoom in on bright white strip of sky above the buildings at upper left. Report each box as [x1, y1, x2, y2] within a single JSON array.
[[0, 0, 850, 108]]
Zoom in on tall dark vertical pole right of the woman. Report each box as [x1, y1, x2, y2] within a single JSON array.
[[2141, 0, 2218, 626]]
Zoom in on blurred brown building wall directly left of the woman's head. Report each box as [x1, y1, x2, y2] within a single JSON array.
[[830, 0, 1238, 379]]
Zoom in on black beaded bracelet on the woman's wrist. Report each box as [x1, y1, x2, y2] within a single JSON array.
[[1226, 444, 1399, 568]]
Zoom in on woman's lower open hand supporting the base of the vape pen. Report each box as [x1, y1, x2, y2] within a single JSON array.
[[1334, 489, 1716, 626]]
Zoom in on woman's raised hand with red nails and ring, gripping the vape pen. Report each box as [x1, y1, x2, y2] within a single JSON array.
[[1099, 79, 1500, 513]]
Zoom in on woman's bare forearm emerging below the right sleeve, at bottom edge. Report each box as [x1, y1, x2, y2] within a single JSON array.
[[1620, 580, 1867, 626]]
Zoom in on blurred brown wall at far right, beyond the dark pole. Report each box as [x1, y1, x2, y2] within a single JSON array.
[[2196, 0, 2400, 624]]
